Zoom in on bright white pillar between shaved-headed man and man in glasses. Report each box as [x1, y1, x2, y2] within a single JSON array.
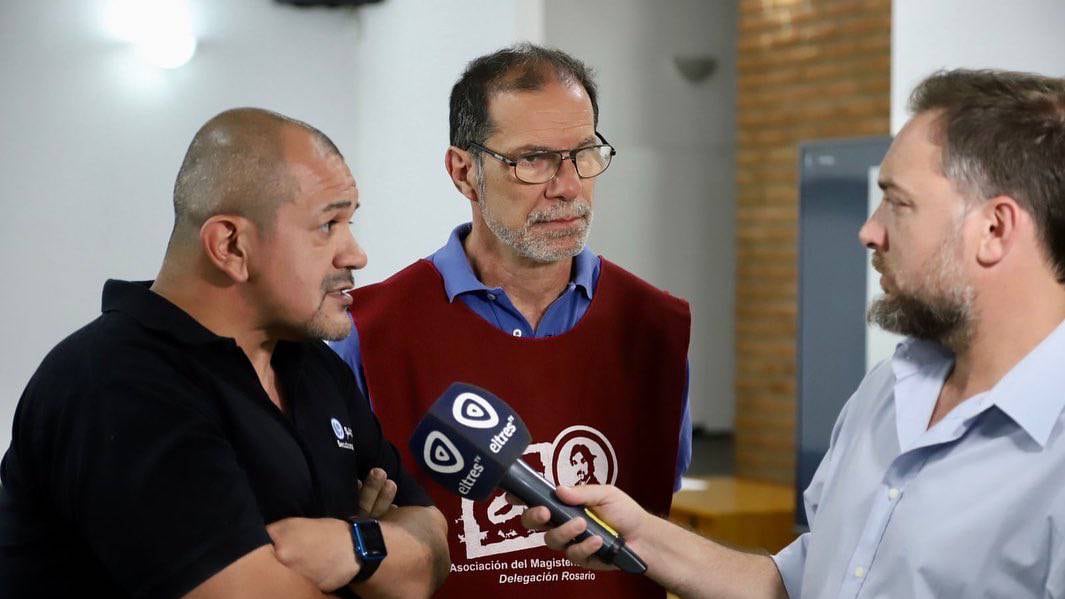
[[345, 0, 543, 285]]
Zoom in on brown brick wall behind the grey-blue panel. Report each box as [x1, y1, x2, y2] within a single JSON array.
[[736, 0, 891, 484]]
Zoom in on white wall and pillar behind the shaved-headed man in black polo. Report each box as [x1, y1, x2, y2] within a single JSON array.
[[0, 0, 532, 451]]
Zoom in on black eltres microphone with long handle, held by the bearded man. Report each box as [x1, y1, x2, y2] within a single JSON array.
[[410, 383, 648, 574]]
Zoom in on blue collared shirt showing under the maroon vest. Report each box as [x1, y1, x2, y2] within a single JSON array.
[[329, 223, 691, 490]]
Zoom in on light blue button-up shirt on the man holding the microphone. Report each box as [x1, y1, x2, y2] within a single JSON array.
[[773, 323, 1065, 599]]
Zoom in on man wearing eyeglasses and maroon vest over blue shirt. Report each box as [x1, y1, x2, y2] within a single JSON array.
[[325, 44, 691, 598]]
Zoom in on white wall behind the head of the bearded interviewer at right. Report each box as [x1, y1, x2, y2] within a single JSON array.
[[867, 0, 1065, 363]]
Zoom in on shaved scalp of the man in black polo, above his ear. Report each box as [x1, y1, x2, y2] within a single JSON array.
[[170, 108, 340, 239]]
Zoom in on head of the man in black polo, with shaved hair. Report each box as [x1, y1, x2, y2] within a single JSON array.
[[151, 108, 366, 343]]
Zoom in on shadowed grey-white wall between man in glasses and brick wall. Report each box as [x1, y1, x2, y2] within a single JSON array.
[[544, 0, 737, 431]]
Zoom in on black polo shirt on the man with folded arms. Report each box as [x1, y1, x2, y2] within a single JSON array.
[[0, 280, 431, 597]]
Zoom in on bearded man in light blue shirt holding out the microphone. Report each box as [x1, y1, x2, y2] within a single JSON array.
[[524, 70, 1065, 599]]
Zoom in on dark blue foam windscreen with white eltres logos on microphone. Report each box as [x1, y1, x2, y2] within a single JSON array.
[[410, 383, 530, 501]]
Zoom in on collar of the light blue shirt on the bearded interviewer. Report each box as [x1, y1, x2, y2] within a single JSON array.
[[891, 322, 1065, 447]]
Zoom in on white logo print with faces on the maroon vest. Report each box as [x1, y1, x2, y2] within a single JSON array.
[[455, 424, 618, 560]]
